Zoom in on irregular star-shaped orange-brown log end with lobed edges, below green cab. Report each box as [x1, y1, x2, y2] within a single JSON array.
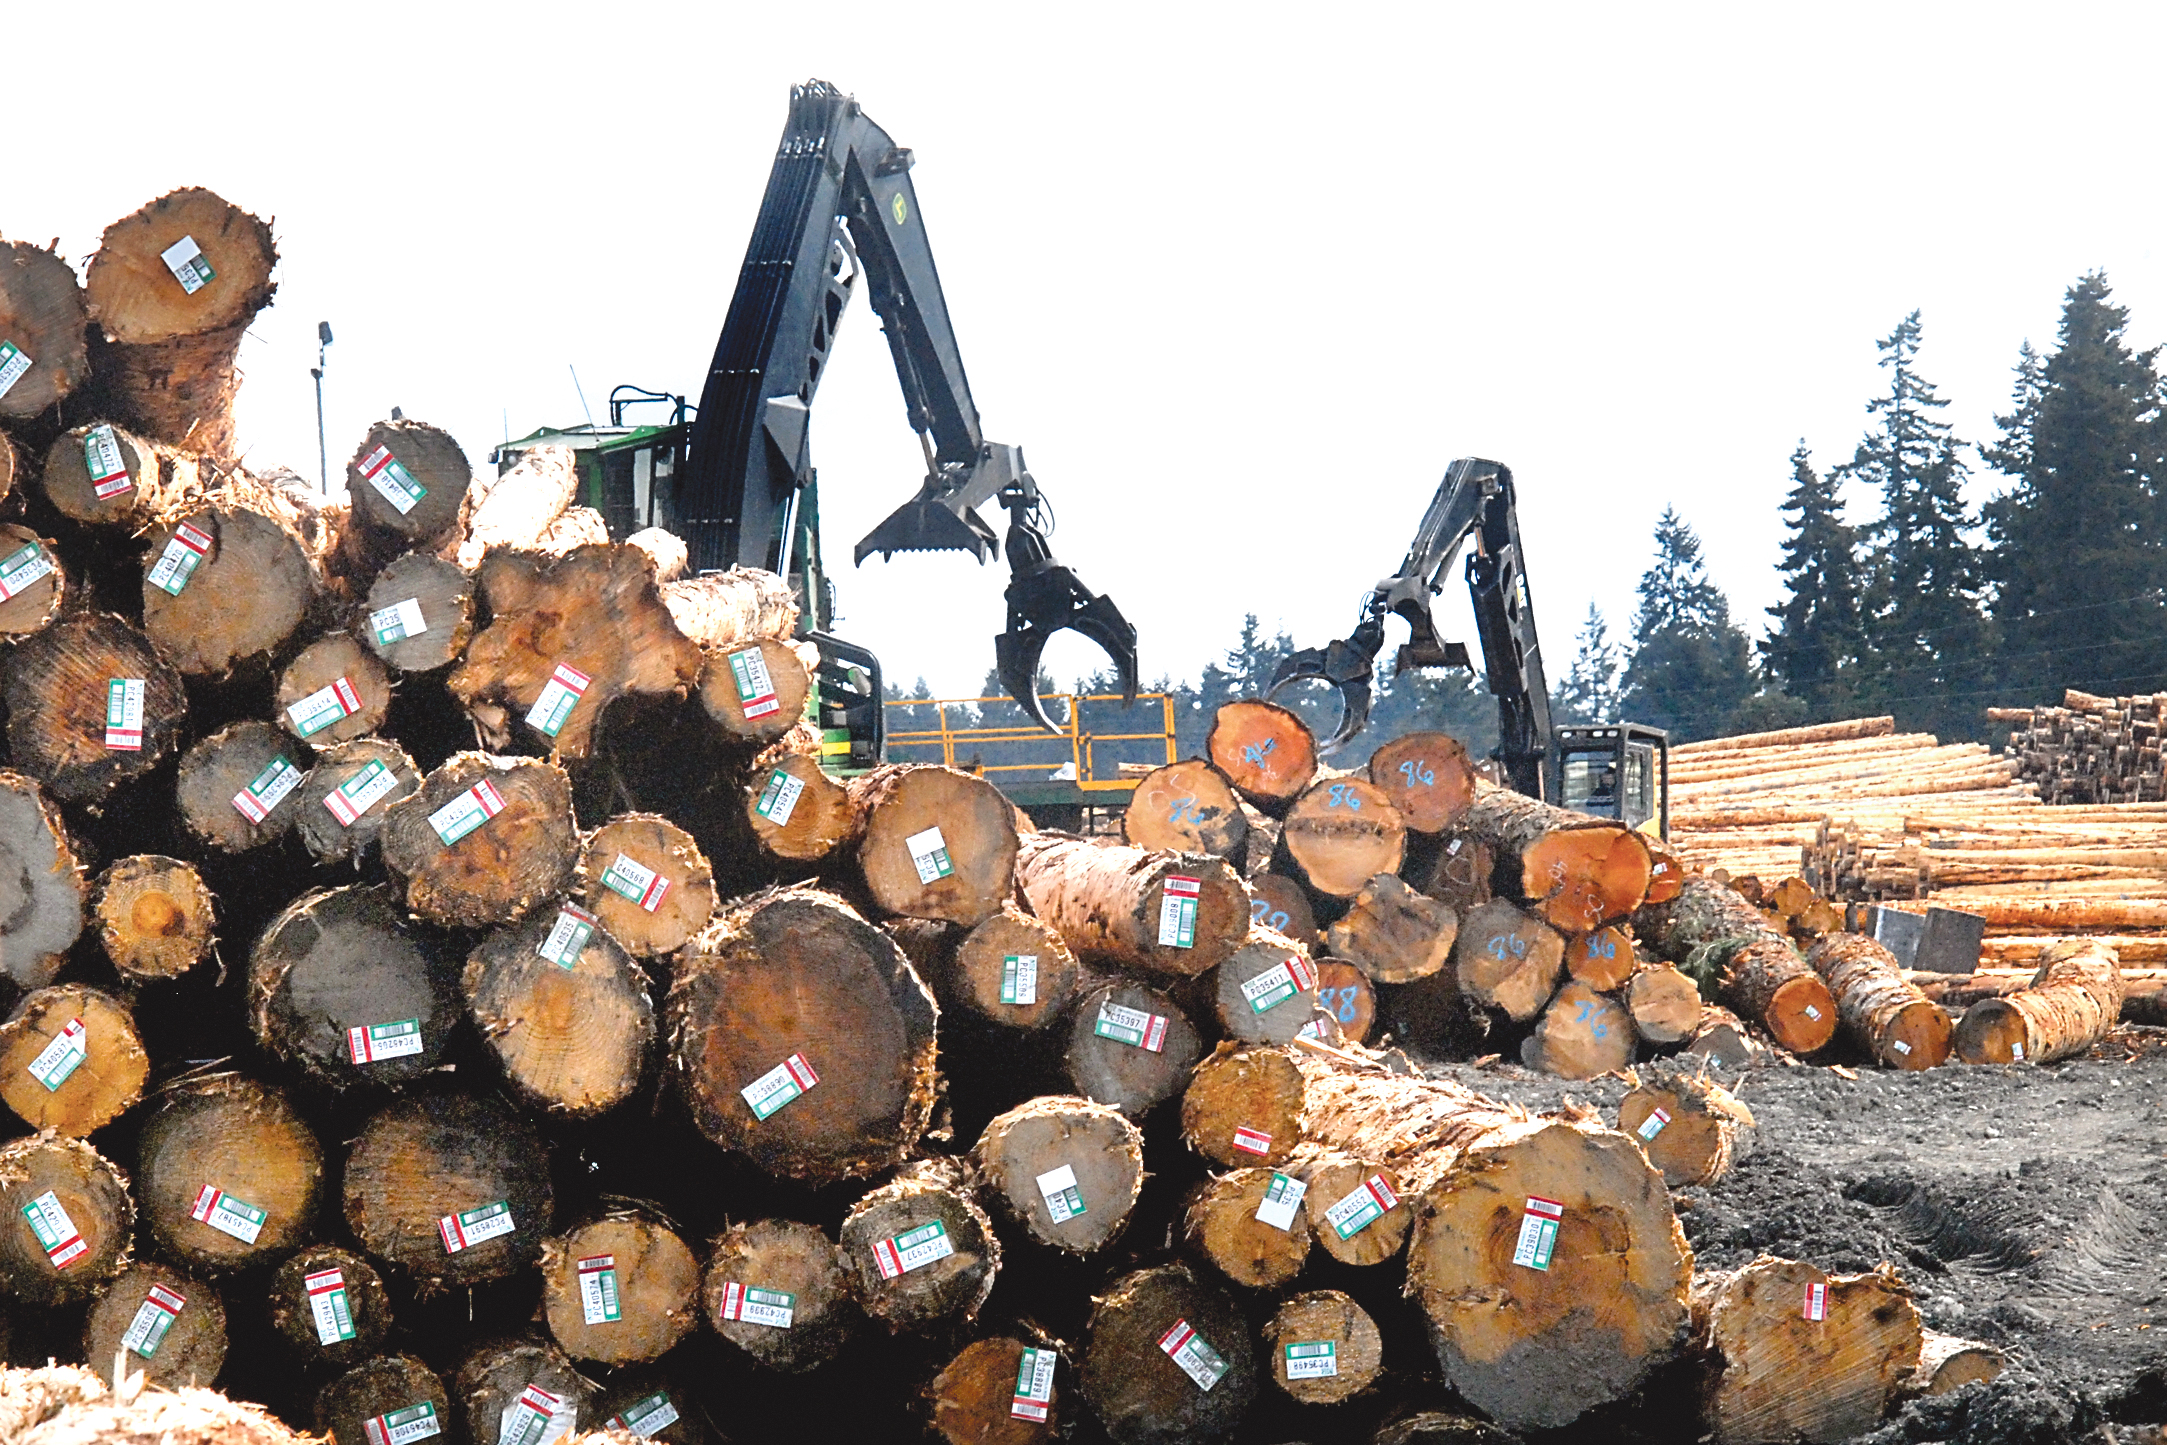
[[444, 541, 700, 758]]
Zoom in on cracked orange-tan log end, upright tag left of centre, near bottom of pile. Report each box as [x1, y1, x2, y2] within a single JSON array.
[[542, 1213, 700, 1365]]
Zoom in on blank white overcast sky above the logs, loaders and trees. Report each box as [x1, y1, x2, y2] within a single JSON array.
[[0, 0, 2167, 693]]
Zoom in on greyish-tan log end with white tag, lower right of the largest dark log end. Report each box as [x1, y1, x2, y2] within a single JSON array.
[[971, 1094, 1144, 1254]]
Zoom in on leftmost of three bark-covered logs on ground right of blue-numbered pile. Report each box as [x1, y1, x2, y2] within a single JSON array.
[[1634, 877, 1835, 1053]]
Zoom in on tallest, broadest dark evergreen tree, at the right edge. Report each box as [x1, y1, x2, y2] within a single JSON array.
[[1987, 273, 2167, 702]]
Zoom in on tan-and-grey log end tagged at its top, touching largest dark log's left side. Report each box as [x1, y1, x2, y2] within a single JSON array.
[[462, 906, 654, 1118]]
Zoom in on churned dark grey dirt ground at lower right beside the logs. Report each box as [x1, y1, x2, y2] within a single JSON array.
[[1435, 1027, 2167, 1445]]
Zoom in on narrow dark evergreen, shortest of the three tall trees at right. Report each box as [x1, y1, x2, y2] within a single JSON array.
[[1760, 438, 1861, 719]]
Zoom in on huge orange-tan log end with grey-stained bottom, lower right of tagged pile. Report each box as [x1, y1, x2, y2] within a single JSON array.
[[1406, 1120, 1692, 1430]]
